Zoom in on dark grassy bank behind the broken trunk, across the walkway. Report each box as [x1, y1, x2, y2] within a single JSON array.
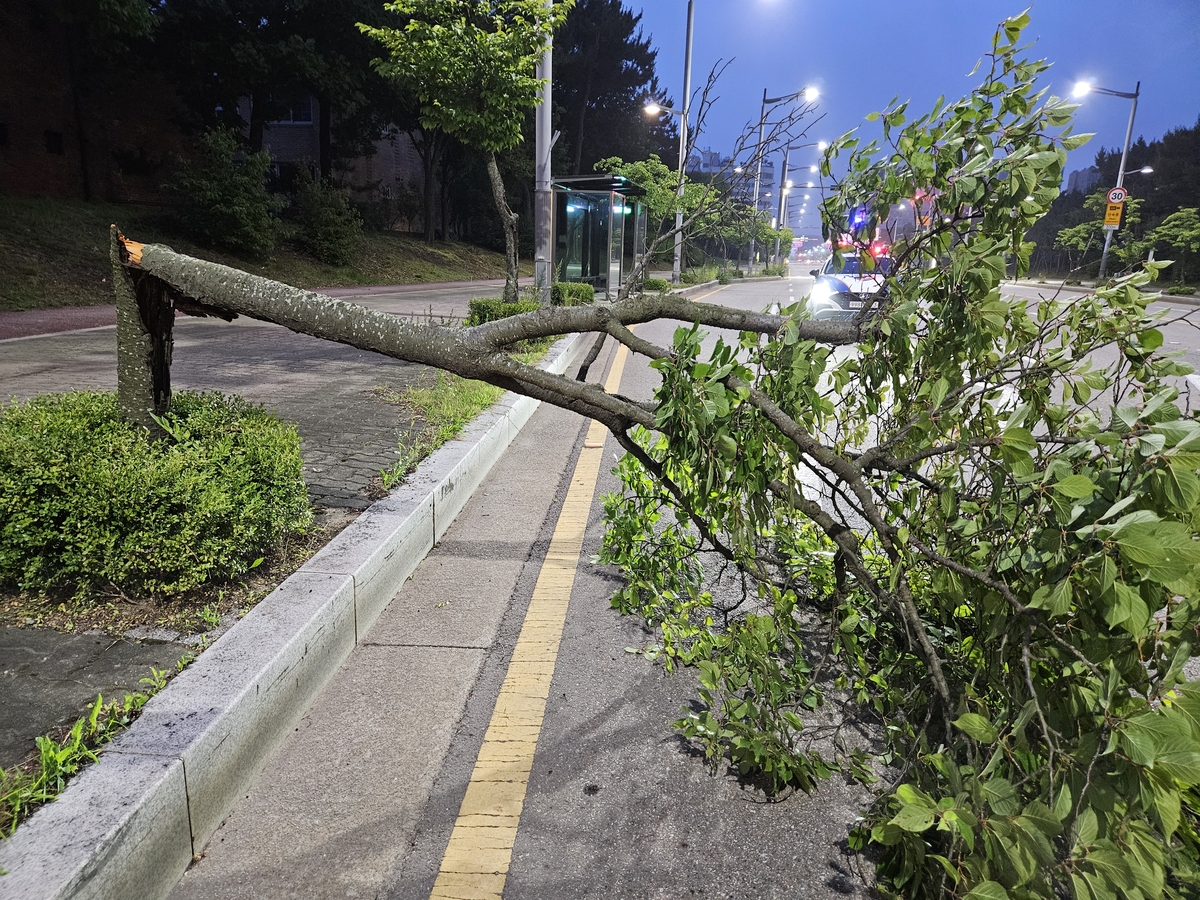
[[0, 194, 532, 312]]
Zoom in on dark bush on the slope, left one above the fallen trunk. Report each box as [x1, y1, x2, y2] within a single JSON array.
[[173, 128, 281, 256]]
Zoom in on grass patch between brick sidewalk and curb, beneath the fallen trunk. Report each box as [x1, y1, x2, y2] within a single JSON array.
[[374, 338, 551, 491]]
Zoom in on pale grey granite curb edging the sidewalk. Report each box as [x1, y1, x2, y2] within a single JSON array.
[[0, 335, 590, 900]]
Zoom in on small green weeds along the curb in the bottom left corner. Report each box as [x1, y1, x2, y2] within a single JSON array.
[[0, 668, 167, 838]]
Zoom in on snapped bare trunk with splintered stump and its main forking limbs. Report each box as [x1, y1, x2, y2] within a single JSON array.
[[113, 226, 859, 432]]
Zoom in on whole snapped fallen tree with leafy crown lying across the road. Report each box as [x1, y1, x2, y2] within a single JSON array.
[[114, 16, 1200, 900]]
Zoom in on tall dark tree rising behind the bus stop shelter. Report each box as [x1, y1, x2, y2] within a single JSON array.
[[554, 0, 674, 175]]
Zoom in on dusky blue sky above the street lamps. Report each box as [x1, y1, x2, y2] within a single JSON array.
[[625, 0, 1200, 236]]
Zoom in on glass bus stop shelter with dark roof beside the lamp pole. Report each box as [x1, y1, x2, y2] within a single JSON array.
[[554, 174, 647, 300]]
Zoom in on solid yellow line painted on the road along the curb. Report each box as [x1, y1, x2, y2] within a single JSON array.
[[430, 344, 629, 900]]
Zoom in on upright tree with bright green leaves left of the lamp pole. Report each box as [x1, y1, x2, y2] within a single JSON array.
[[359, 0, 572, 302]]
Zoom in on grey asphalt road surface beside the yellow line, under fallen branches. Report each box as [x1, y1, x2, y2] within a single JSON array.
[[385, 280, 868, 900]]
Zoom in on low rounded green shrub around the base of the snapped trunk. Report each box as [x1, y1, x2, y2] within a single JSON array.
[[0, 391, 311, 599]]
